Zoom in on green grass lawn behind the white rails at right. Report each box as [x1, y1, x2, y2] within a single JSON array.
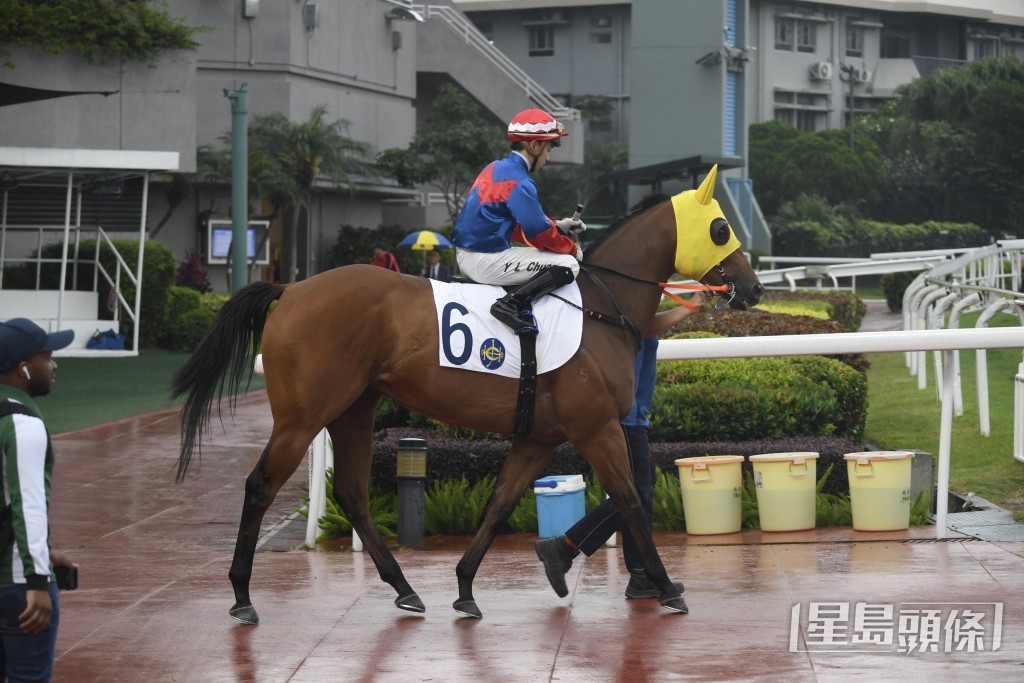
[[865, 314, 1024, 519]]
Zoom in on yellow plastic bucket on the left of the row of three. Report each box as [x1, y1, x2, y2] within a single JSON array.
[[676, 456, 743, 535]]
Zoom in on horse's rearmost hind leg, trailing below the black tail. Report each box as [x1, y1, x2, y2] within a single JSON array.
[[227, 424, 314, 624]]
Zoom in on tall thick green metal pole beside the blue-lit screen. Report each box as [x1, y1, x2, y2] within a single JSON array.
[[224, 83, 249, 292]]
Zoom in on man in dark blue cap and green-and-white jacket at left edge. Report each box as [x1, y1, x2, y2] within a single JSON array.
[[0, 317, 77, 681]]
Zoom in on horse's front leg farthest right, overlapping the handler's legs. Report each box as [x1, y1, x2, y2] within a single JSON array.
[[575, 423, 689, 613]]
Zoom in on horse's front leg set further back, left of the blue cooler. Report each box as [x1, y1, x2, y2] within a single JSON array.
[[452, 437, 554, 618]]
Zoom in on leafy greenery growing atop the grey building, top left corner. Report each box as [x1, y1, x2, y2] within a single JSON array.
[[0, 0, 209, 69]]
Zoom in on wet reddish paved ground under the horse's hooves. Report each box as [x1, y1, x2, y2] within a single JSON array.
[[51, 392, 1024, 682]]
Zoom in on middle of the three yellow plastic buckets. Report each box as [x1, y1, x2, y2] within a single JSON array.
[[750, 453, 818, 531]]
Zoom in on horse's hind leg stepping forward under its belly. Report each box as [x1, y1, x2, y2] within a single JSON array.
[[328, 390, 426, 612]]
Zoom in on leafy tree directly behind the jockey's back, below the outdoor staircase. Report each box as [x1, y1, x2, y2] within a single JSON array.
[[377, 83, 506, 223]]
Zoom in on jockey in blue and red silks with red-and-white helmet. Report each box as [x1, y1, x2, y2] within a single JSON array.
[[453, 109, 587, 335]]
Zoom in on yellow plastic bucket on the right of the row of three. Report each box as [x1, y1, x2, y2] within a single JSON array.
[[843, 451, 913, 531]]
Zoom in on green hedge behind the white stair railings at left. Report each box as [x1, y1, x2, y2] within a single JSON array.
[[4, 240, 177, 348]]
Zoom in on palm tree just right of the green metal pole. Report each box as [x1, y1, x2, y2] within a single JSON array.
[[249, 104, 370, 283]]
